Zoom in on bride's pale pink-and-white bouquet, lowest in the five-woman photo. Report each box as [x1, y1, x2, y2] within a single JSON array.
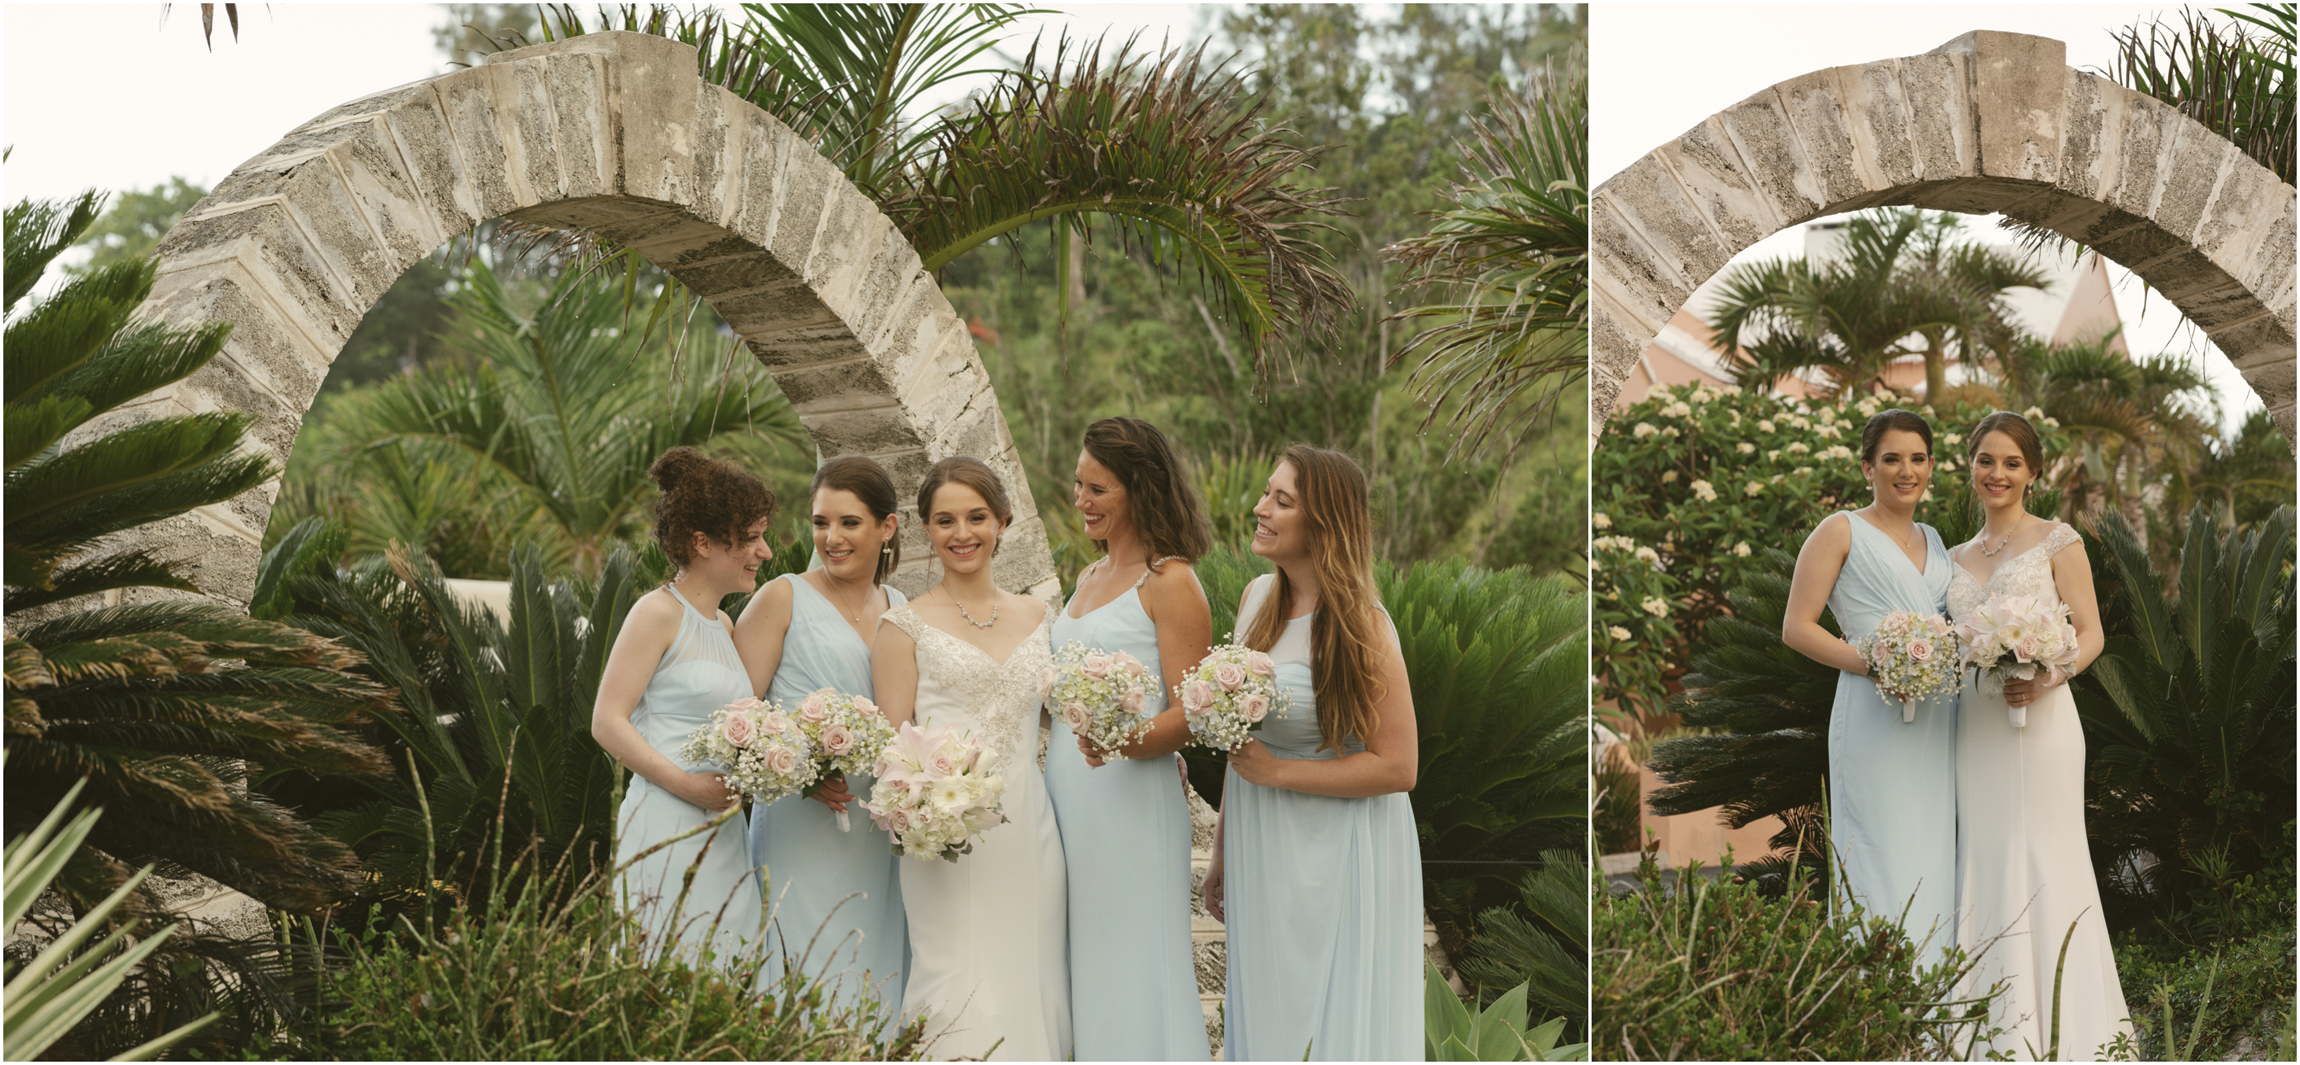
[[863, 725, 1005, 863]]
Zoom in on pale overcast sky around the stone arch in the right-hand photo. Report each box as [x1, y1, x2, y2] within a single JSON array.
[[1589, 5, 2261, 428]]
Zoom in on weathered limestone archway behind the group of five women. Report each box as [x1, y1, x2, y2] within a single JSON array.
[[128, 32, 1056, 603]]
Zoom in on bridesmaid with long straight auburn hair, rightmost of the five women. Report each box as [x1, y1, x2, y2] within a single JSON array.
[[1205, 444, 1424, 1060]]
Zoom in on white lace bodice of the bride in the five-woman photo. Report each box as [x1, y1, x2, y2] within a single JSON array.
[[886, 605, 1053, 773]]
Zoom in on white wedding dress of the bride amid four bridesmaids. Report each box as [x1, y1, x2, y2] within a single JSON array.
[[886, 605, 1072, 1060]]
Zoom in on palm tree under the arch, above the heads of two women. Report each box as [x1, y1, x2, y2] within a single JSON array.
[[1709, 209, 2045, 398]]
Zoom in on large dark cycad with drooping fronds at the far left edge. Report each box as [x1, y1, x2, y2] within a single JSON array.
[[5, 193, 396, 911]]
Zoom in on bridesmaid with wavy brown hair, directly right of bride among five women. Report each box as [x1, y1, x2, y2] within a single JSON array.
[[1047, 419, 1214, 1060]]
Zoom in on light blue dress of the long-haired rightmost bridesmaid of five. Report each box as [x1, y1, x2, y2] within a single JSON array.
[[1221, 577, 1424, 1060]]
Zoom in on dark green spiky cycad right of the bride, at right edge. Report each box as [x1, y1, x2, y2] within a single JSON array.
[[2075, 506, 2295, 904]]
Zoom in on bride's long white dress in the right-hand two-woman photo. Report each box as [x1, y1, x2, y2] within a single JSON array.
[[1948, 524, 2132, 1060]]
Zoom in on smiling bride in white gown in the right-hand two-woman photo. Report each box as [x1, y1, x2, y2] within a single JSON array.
[[1948, 412, 2132, 1058]]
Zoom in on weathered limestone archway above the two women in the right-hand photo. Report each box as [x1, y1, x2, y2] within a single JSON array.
[[1589, 30, 2300, 442]]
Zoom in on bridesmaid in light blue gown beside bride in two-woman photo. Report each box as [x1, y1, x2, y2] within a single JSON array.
[[1780, 409, 1957, 950]]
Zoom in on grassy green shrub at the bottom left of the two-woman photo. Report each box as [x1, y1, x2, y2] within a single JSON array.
[[1589, 856, 1987, 1060]]
